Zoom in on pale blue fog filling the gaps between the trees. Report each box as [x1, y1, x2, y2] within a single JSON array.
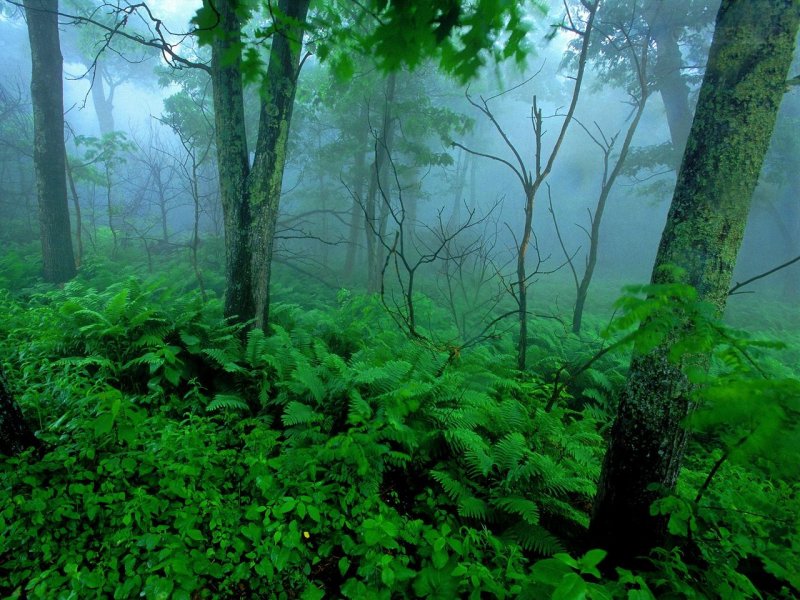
[[0, 0, 800, 318]]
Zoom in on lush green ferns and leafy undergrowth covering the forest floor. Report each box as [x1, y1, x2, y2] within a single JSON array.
[[0, 263, 800, 599]]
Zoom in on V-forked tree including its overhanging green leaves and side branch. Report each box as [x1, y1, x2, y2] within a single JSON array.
[[45, 0, 544, 327]]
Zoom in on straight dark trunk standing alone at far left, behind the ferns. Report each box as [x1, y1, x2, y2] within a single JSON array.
[[24, 0, 75, 283]]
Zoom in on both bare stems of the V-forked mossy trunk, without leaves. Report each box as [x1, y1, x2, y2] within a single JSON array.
[[211, 0, 309, 328]]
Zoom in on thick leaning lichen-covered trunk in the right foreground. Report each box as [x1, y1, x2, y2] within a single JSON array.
[[590, 0, 800, 562]]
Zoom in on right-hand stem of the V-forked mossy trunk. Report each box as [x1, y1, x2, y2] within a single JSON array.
[[248, 0, 310, 329]]
